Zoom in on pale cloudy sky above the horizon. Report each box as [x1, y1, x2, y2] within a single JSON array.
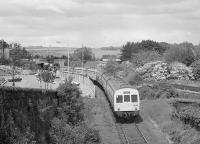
[[0, 0, 200, 48]]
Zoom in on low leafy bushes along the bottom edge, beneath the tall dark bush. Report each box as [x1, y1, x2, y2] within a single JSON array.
[[50, 118, 100, 144]]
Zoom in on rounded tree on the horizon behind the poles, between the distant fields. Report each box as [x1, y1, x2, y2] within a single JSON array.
[[73, 47, 95, 63]]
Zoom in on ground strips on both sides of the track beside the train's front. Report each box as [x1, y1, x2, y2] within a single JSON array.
[[84, 87, 169, 144]]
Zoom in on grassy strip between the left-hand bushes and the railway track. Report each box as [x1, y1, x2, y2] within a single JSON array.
[[83, 87, 120, 144]]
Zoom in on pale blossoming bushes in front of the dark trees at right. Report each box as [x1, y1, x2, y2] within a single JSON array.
[[136, 61, 194, 81]]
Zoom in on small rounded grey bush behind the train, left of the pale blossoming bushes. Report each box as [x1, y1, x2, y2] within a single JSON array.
[[104, 61, 122, 76]]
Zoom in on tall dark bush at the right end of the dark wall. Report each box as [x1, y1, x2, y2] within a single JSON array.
[[57, 78, 83, 125]]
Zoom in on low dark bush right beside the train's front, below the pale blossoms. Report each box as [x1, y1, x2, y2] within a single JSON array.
[[139, 83, 179, 99]]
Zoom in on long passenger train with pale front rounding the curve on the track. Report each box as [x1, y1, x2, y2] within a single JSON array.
[[68, 68, 140, 117]]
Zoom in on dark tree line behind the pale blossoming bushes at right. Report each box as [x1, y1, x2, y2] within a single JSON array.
[[120, 40, 200, 66]]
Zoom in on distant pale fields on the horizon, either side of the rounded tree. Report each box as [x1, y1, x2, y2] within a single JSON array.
[[26, 47, 120, 58]]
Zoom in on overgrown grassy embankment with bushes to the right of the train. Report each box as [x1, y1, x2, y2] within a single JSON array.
[[140, 82, 200, 144]]
